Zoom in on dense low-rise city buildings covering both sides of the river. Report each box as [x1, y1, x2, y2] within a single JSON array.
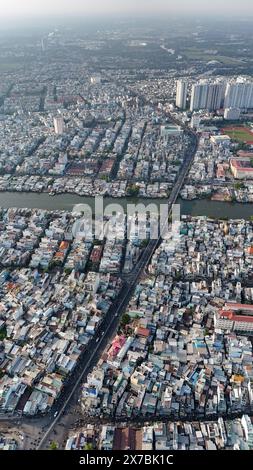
[[0, 19, 253, 451]]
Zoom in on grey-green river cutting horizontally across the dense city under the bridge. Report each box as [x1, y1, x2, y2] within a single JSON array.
[[0, 192, 253, 219]]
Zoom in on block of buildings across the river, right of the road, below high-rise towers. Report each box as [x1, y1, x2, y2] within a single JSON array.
[[180, 126, 253, 203]]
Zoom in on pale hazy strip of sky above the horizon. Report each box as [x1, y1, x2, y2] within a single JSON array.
[[0, 0, 253, 19]]
